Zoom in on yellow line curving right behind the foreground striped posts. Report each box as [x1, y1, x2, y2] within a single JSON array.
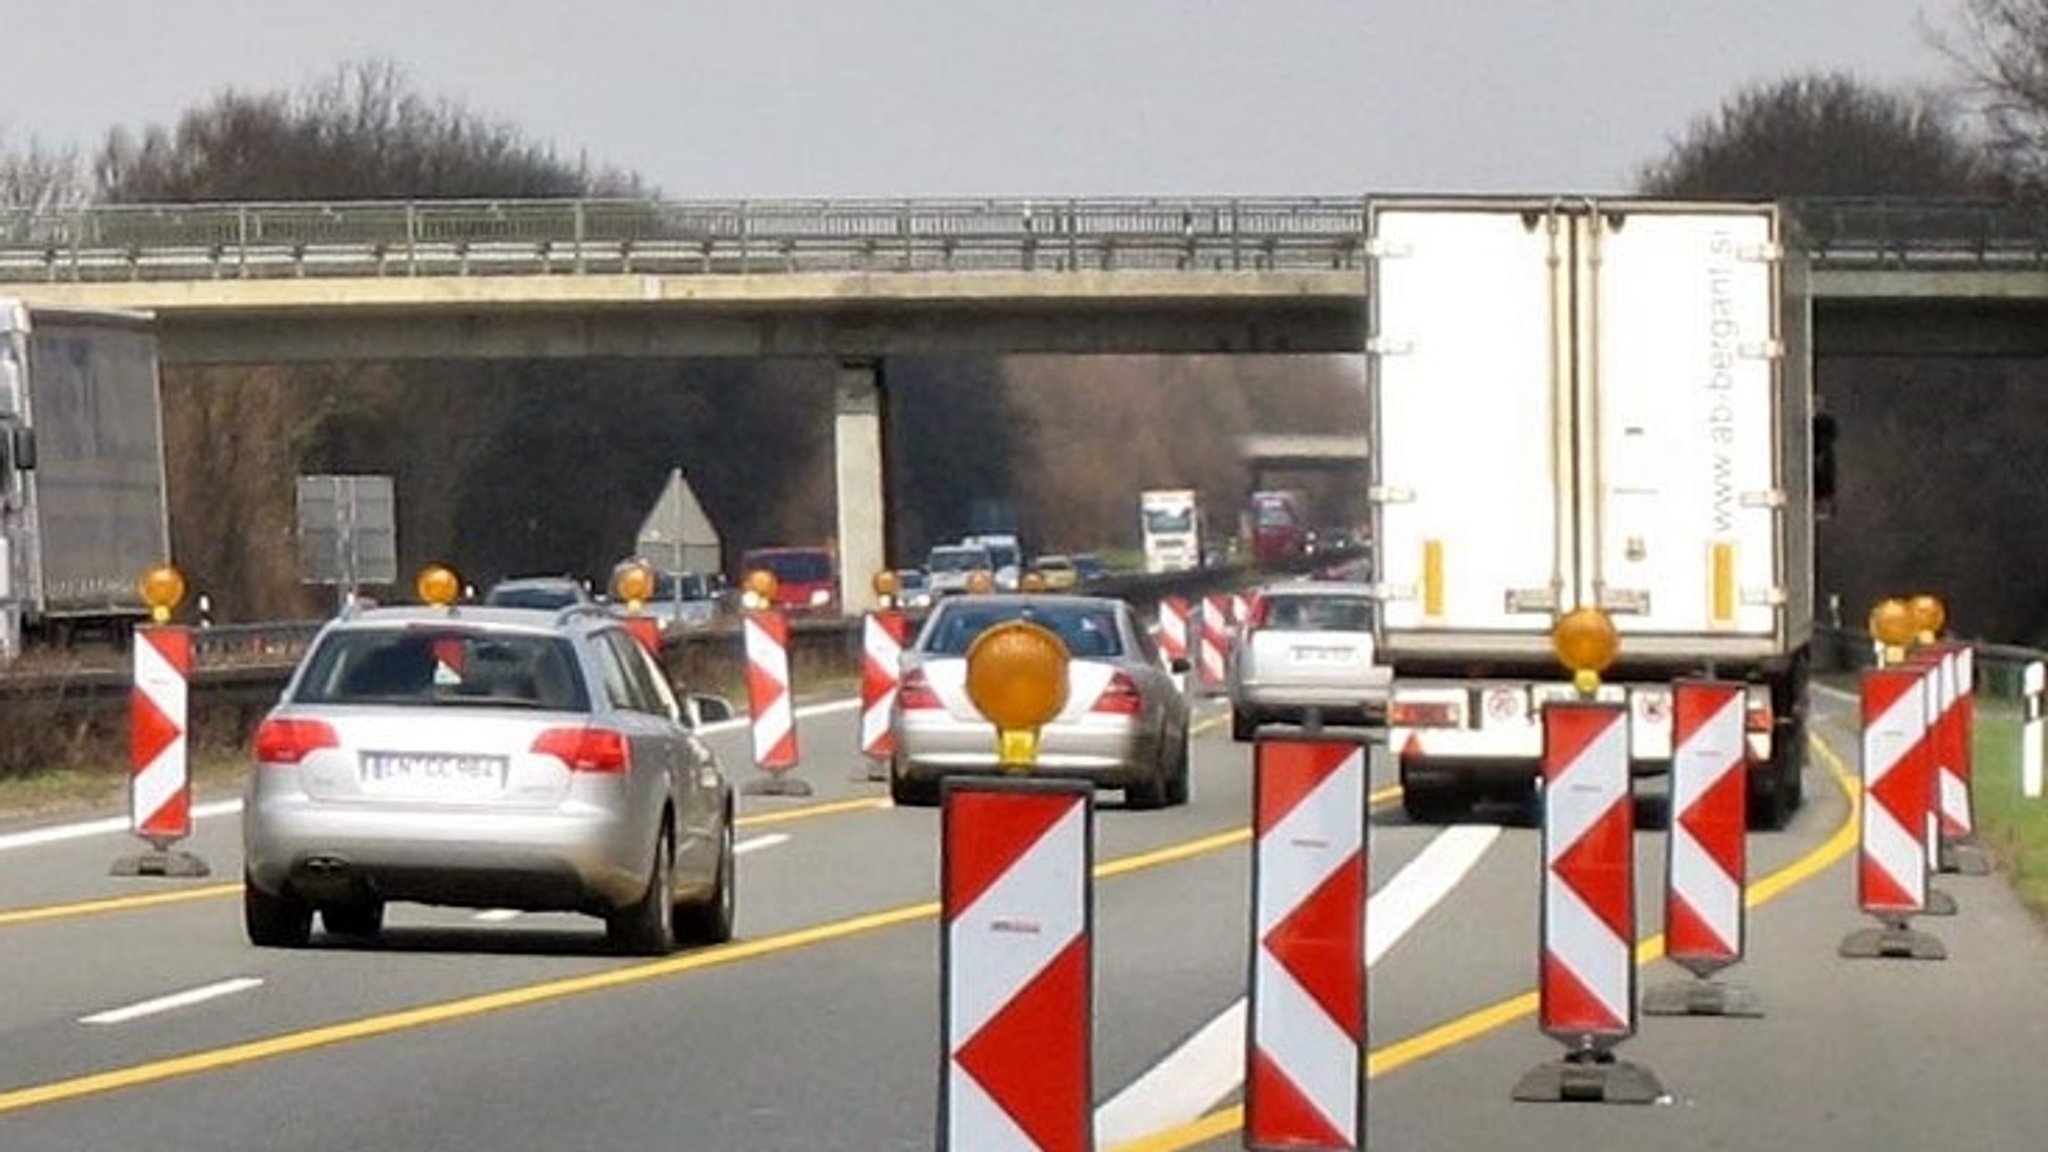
[[1110, 736, 1862, 1152]]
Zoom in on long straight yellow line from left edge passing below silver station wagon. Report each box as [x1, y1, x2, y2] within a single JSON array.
[[0, 774, 1399, 1115]]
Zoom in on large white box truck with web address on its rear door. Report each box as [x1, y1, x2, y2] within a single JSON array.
[[1366, 199, 1815, 828]]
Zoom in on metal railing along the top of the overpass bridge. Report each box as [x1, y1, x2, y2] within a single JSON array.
[[12, 197, 2048, 283]]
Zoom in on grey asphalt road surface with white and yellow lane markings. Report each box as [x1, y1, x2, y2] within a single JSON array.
[[0, 684, 2048, 1152]]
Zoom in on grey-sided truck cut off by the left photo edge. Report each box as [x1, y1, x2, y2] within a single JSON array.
[[0, 299, 170, 662]]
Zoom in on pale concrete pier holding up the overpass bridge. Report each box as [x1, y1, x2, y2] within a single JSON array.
[[831, 359, 889, 613]]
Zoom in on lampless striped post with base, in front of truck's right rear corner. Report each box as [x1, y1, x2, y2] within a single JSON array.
[[1642, 681, 1763, 1017]]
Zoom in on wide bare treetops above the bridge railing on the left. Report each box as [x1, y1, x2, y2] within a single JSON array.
[[94, 59, 641, 203]]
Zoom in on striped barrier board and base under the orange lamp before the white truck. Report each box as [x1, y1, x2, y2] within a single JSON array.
[[1516, 699, 1665, 1105]]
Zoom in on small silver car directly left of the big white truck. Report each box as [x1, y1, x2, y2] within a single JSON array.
[[1227, 580, 1393, 740]]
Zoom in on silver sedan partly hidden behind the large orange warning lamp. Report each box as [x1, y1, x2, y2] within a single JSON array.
[[889, 592, 1188, 808]]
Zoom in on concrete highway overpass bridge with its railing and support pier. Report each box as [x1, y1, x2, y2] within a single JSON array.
[[0, 197, 2048, 605]]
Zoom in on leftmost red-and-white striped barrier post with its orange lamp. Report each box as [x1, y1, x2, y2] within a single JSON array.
[[111, 566, 211, 877]]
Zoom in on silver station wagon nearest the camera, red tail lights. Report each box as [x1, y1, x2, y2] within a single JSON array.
[[242, 590, 735, 955]]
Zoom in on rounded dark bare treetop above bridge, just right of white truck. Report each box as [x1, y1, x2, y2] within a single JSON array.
[[1638, 72, 1995, 197]]
